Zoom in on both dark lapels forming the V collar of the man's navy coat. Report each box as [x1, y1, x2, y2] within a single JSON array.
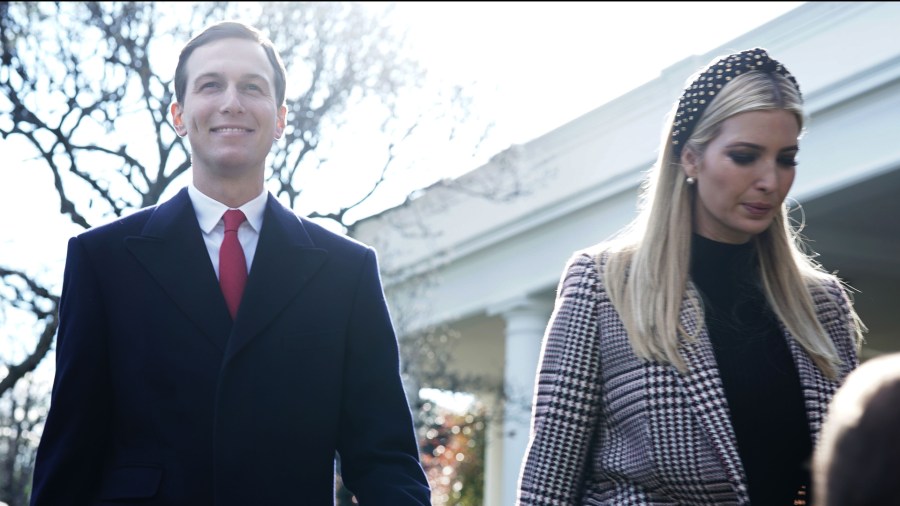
[[125, 189, 328, 360]]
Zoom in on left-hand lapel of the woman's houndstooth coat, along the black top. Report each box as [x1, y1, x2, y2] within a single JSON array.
[[680, 283, 750, 504]]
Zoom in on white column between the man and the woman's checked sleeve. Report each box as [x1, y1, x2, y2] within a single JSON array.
[[485, 297, 553, 506]]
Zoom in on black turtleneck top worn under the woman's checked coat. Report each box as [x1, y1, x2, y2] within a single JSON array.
[[691, 234, 812, 506]]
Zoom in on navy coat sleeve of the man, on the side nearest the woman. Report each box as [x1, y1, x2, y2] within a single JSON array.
[[338, 249, 431, 506]]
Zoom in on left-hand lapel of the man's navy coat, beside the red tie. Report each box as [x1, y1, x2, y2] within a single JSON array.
[[125, 189, 231, 350]]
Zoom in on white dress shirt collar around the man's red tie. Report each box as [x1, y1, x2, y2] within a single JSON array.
[[188, 183, 269, 278]]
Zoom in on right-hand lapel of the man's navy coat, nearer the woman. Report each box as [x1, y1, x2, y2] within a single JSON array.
[[223, 195, 328, 361]]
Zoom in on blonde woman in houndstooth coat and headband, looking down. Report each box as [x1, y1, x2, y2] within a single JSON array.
[[519, 48, 864, 506]]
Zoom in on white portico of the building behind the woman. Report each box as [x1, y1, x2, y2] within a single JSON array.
[[355, 2, 900, 506]]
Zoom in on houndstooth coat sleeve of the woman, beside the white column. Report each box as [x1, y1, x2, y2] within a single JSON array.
[[517, 254, 602, 506]]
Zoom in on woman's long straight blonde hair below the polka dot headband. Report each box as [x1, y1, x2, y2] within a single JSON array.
[[600, 71, 865, 378]]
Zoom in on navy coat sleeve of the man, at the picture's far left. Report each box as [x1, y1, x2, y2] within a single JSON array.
[[31, 237, 111, 506]]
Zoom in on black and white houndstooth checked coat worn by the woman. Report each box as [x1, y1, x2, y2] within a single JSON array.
[[517, 251, 858, 506]]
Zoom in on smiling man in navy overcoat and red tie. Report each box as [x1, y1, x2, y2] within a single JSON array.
[[31, 22, 430, 506]]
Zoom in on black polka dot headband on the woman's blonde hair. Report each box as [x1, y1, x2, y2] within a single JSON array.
[[672, 47, 800, 157]]
